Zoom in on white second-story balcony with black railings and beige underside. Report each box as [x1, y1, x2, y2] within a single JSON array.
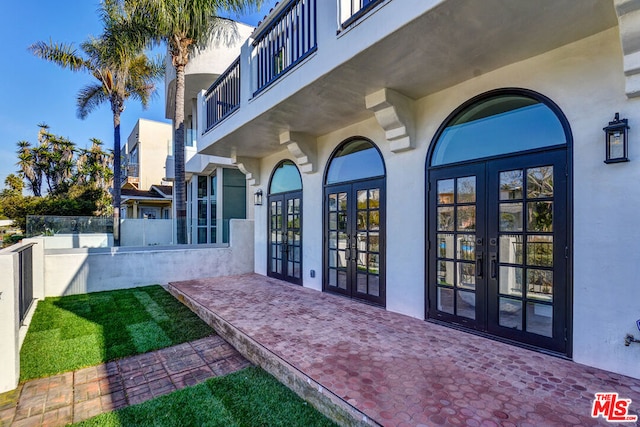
[[197, 0, 617, 158]]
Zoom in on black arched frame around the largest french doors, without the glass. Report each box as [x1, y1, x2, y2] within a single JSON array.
[[424, 87, 574, 358]]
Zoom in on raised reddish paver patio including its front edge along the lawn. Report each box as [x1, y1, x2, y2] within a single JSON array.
[[170, 274, 640, 426]]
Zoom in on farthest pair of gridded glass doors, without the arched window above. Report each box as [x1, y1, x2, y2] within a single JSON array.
[[267, 191, 302, 285]]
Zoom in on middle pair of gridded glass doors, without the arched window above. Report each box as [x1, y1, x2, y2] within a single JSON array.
[[324, 179, 385, 306]]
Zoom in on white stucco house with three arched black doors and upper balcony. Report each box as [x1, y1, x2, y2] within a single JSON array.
[[192, 0, 640, 377]]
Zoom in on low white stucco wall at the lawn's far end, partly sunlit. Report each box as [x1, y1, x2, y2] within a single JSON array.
[[44, 220, 253, 296]]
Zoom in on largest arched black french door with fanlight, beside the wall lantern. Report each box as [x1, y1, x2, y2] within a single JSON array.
[[427, 89, 571, 355]]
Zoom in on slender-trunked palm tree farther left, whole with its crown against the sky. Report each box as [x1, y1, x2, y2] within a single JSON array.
[[30, 0, 164, 246]]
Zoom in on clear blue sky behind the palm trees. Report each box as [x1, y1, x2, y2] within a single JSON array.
[[0, 0, 276, 189]]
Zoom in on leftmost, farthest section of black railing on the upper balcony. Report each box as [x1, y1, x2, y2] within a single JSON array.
[[205, 58, 240, 131]]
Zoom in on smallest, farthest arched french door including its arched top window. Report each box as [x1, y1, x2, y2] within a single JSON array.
[[267, 160, 302, 285]]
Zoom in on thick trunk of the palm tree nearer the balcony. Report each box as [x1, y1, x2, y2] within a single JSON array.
[[173, 64, 187, 244]]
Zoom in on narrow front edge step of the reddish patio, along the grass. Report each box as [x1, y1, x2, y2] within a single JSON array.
[[168, 283, 380, 426]]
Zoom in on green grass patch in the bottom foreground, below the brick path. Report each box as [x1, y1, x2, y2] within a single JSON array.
[[77, 367, 335, 427]]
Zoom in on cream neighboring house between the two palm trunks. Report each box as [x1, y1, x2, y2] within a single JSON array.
[[121, 119, 173, 219]]
